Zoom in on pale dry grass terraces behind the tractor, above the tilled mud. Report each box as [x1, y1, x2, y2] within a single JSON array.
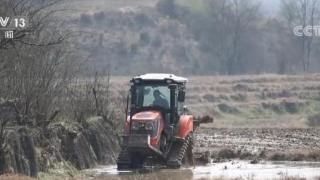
[[112, 74, 320, 128]]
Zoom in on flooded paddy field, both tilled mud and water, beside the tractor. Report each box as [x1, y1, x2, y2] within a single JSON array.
[[85, 127, 320, 180]]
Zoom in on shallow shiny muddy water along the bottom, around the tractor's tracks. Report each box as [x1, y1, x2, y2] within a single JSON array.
[[84, 161, 320, 180]]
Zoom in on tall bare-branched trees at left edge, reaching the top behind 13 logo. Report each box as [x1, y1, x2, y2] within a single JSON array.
[[0, 0, 75, 125]]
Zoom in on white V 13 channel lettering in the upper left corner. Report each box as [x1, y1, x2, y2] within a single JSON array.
[[0, 17, 28, 30]]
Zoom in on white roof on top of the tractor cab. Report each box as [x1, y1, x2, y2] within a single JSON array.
[[133, 73, 188, 83]]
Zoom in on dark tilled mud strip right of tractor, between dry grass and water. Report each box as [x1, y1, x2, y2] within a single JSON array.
[[194, 128, 320, 163]]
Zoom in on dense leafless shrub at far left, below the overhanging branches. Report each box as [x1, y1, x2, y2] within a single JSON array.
[[0, 45, 74, 125]]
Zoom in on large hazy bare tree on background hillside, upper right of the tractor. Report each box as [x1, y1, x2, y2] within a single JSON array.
[[205, 0, 260, 74]]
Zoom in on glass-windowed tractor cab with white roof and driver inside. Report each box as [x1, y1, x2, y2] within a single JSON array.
[[130, 74, 187, 125]]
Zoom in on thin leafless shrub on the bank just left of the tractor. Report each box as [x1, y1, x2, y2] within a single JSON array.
[[64, 73, 126, 131]]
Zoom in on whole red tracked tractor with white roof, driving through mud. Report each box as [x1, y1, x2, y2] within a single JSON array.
[[117, 74, 194, 170]]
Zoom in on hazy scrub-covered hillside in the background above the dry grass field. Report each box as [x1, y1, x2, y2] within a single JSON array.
[[63, 0, 320, 75]]
